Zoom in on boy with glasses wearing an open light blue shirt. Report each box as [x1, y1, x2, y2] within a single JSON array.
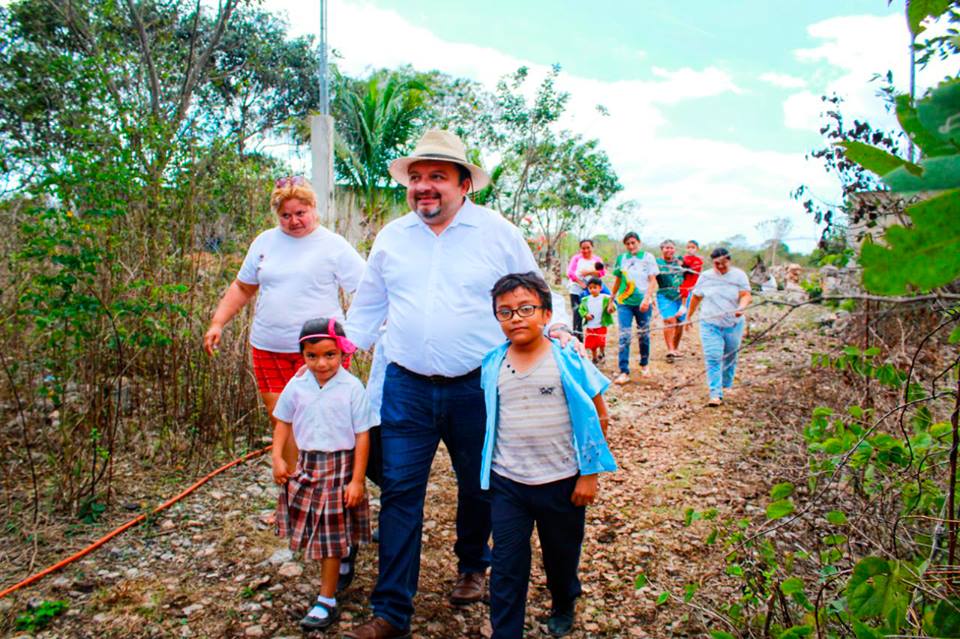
[[480, 273, 617, 639]]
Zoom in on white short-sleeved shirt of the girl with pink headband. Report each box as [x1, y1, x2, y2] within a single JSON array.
[[273, 367, 380, 453]]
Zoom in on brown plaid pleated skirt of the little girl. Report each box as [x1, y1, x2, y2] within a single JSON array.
[[277, 450, 370, 561]]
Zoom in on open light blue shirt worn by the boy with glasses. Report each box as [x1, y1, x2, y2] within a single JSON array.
[[480, 341, 617, 490]]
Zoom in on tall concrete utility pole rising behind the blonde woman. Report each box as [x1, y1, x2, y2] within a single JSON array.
[[310, 0, 336, 229]]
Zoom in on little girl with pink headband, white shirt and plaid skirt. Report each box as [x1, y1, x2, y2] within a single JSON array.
[[273, 318, 379, 631]]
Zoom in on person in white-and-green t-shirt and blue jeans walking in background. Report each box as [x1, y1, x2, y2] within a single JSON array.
[[610, 231, 660, 384]]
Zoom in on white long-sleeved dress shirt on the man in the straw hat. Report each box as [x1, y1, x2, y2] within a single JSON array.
[[346, 199, 567, 377]]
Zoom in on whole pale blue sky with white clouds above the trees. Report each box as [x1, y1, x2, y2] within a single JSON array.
[[266, 0, 950, 249]]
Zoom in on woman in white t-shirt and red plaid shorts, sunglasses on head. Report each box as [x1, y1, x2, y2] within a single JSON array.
[[203, 176, 364, 466]]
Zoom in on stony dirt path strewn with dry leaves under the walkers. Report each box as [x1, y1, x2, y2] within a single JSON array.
[[0, 308, 823, 638]]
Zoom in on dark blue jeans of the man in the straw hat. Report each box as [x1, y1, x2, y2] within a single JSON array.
[[370, 364, 490, 629]]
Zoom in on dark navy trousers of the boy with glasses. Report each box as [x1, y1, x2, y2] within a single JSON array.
[[490, 472, 586, 639]]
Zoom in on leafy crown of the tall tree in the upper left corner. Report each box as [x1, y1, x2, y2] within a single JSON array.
[[0, 0, 317, 184]]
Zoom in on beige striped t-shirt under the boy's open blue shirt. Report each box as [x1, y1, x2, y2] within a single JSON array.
[[491, 352, 579, 485]]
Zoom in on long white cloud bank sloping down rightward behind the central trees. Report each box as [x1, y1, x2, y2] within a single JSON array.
[[267, 0, 835, 248]]
